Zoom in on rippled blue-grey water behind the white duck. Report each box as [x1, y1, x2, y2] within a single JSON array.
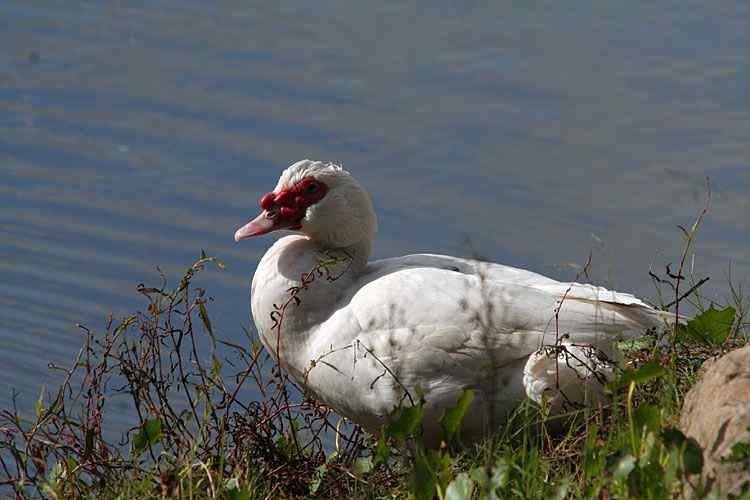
[[0, 0, 750, 434]]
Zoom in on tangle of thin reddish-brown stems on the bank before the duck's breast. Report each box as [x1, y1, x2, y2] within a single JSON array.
[[0, 254, 363, 498]]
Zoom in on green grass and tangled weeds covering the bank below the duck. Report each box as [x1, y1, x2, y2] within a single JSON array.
[[0, 198, 750, 500]]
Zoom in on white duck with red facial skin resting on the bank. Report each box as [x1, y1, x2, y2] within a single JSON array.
[[234, 160, 668, 443]]
